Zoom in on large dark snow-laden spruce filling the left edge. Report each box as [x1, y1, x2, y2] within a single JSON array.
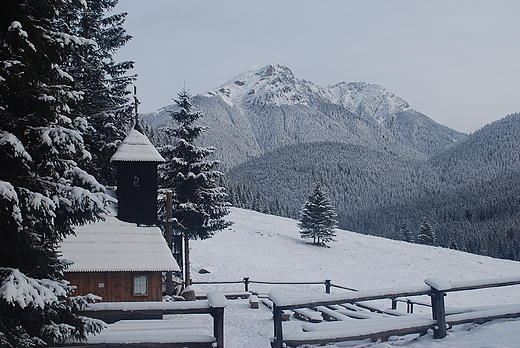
[[0, 0, 108, 348]]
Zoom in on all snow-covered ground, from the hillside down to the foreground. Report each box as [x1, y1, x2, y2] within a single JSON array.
[[191, 209, 520, 348]]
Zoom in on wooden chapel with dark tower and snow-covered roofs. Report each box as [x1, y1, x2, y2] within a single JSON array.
[[60, 127, 180, 302]]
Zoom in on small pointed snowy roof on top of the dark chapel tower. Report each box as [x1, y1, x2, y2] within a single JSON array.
[[110, 128, 164, 163]]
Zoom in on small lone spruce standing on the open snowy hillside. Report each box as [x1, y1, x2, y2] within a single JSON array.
[[298, 184, 338, 246]]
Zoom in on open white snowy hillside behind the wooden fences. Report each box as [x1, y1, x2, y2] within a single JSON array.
[[191, 208, 520, 296]]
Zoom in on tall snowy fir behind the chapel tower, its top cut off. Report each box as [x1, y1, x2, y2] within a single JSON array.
[[69, 0, 136, 185]]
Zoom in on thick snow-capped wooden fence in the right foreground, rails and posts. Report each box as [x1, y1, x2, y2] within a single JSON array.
[[269, 277, 520, 348]]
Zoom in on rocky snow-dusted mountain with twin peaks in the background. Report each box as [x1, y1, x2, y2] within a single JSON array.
[[143, 64, 466, 169]]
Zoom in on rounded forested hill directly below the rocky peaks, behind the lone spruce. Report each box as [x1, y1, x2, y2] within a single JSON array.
[[228, 142, 421, 219]]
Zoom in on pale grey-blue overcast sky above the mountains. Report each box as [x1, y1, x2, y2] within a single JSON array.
[[116, 0, 520, 133]]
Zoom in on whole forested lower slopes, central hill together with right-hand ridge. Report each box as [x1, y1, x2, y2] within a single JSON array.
[[229, 114, 520, 259]]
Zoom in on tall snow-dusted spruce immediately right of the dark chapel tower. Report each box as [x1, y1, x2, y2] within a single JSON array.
[[159, 89, 231, 286]]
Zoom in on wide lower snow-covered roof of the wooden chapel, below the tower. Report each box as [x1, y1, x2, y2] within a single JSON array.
[[60, 215, 179, 272]]
